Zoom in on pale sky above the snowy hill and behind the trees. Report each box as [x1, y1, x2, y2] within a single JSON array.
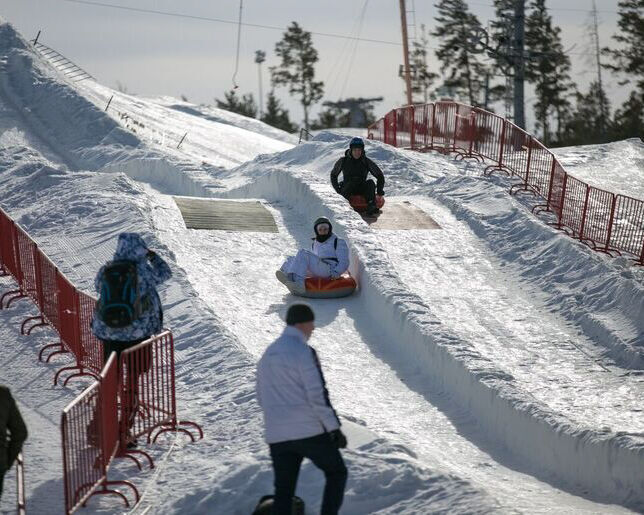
[[0, 0, 630, 129]]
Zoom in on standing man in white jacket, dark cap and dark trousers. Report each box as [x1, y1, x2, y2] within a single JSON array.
[[256, 304, 347, 515]]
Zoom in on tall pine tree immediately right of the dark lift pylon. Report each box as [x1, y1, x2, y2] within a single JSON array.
[[525, 0, 574, 145]]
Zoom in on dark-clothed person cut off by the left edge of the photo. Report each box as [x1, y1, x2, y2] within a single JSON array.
[[0, 385, 27, 498]]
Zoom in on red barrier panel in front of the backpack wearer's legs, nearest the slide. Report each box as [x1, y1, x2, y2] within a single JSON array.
[[119, 331, 203, 458]]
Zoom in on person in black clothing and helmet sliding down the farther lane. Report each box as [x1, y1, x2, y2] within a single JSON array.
[[331, 138, 385, 215]]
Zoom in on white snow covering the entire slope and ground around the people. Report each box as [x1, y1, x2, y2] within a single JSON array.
[[0, 18, 644, 514]]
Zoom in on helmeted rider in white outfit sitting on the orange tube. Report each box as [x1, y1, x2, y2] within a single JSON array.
[[275, 217, 349, 292]]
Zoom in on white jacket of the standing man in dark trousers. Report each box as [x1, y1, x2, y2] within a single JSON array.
[[256, 326, 340, 444]]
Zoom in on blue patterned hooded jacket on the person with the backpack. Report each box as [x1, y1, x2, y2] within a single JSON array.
[[92, 232, 172, 342]]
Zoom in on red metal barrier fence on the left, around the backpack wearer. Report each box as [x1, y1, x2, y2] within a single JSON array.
[[0, 208, 203, 513]]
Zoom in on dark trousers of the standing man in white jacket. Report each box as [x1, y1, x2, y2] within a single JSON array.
[[270, 433, 347, 515]]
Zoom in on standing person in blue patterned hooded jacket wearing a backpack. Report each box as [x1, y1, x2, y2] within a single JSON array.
[[91, 232, 172, 440]]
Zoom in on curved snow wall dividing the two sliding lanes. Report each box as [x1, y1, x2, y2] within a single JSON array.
[[217, 168, 644, 510]]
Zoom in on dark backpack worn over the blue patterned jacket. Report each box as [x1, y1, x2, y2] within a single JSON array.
[[96, 259, 145, 329]]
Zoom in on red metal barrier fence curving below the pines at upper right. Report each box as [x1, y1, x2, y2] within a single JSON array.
[[368, 102, 644, 265]]
